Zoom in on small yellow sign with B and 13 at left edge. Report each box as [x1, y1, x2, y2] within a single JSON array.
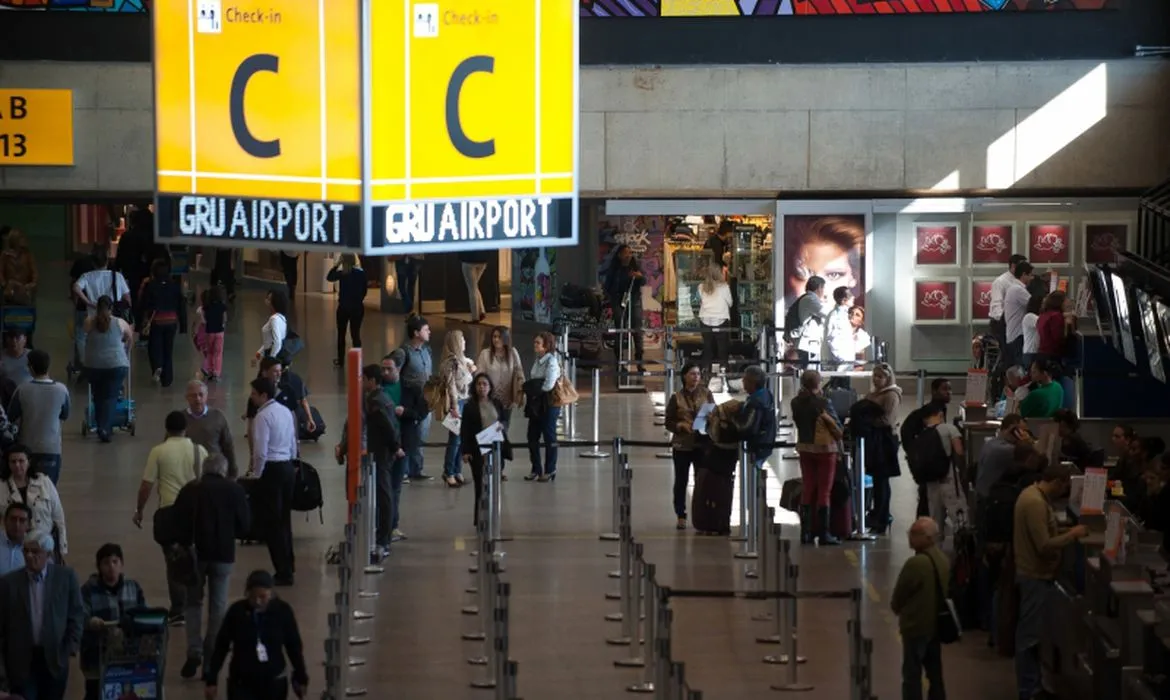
[[0, 89, 74, 166]]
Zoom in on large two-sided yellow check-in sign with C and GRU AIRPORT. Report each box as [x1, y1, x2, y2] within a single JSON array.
[[153, 0, 578, 255]]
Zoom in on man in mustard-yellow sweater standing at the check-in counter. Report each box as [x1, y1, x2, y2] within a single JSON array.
[[1012, 460, 1088, 700]]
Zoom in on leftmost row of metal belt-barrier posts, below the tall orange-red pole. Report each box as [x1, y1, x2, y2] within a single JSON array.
[[323, 458, 385, 700]]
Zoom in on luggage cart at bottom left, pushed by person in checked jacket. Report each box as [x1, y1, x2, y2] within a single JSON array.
[[98, 609, 167, 700]]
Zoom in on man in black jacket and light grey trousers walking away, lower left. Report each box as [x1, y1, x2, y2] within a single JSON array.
[[173, 454, 252, 679]]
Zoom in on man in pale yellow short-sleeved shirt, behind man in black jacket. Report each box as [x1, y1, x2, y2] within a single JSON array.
[[133, 411, 207, 625]]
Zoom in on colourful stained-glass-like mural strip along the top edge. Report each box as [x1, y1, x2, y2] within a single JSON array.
[[580, 0, 1121, 18]]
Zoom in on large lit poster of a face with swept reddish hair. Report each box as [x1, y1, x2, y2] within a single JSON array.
[[784, 214, 866, 307]]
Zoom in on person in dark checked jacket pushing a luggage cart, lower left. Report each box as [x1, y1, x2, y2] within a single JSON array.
[[81, 544, 146, 700]]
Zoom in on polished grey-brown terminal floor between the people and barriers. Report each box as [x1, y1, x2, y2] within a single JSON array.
[[27, 263, 1013, 700]]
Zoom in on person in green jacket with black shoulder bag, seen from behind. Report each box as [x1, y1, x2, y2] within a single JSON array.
[[889, 517, 950, 700]]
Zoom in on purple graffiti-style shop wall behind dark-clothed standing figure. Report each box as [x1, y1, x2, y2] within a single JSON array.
[[598, 217, 667, 348]]
